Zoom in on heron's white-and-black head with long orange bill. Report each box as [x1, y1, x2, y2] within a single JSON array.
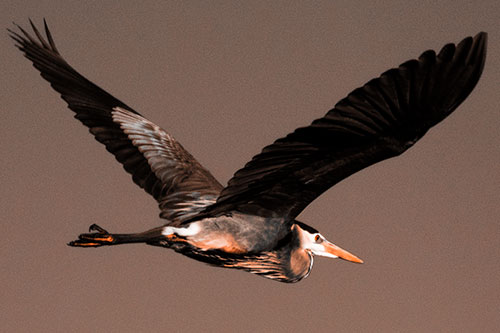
[[294, 221, 363, 264]]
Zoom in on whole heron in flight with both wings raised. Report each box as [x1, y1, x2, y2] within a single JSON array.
[[9, 20, 487, 282]]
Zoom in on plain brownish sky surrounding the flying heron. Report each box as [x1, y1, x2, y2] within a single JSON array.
[[0, 0, 500, 332]]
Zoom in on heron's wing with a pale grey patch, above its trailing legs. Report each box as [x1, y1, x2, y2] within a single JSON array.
[[9, 20, 222, 224]]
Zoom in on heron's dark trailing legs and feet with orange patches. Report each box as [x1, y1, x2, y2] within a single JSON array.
[[68, 224, 161, 247]]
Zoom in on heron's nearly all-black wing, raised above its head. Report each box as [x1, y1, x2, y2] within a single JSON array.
[[204, 32, 487, 221]]
